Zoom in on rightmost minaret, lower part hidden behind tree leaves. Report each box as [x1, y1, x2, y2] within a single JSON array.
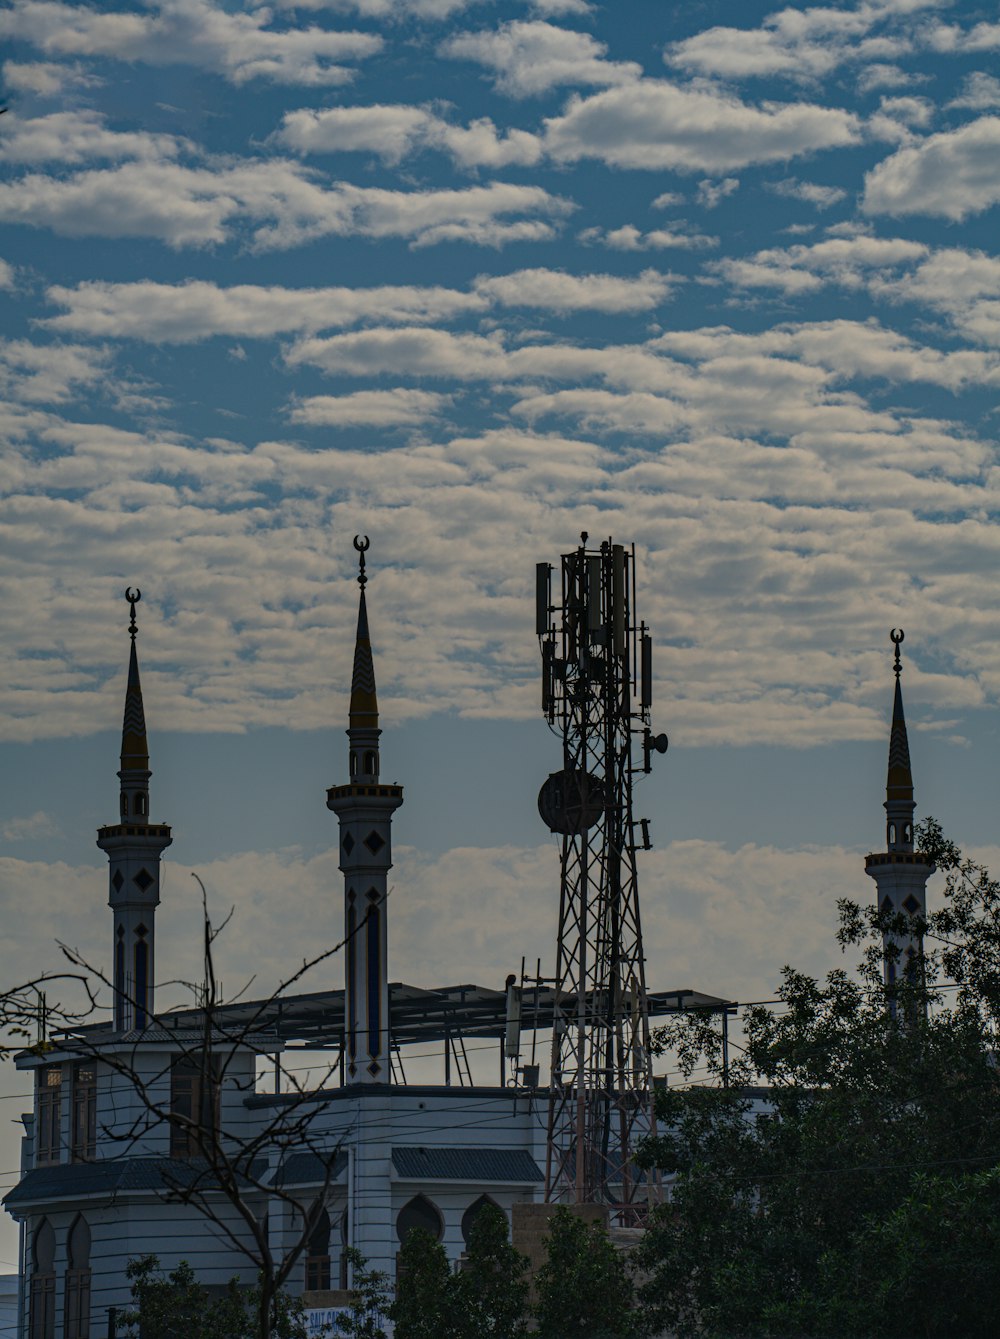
[[865, 628, 934, 1015]]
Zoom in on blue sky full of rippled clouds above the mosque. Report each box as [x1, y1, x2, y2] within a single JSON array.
[[0, 0, 1000, 1268]]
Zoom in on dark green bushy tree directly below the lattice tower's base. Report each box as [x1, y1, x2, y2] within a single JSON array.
[[534, 1206, 640, 1339]]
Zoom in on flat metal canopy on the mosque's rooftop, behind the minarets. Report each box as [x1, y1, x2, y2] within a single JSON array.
[[95, 981, 738, 1050]]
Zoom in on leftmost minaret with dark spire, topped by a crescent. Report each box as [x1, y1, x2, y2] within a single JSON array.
[[98, 588, 173, 1032]]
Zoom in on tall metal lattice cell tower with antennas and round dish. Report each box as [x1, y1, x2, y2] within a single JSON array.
[[535, 532, 667, 1223]]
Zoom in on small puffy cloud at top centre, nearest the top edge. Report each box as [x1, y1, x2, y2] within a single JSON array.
[[440, 20, 643, 98]]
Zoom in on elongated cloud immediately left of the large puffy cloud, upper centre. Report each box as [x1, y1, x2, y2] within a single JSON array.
[[276, 104, 542, 167]]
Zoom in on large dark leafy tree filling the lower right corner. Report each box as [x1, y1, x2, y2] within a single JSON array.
[[640, 822, 1000, 1339]]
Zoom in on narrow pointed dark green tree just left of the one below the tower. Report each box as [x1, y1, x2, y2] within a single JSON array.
[[452, 1204, 527, 1339]]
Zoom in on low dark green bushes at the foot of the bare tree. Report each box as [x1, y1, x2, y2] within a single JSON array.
[[118, 1255, 307, 1339]]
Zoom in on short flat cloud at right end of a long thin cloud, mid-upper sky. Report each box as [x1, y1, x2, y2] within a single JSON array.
[[475, 269, 671, 312]]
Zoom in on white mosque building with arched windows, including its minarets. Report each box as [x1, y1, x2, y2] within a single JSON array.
[[4, 544, 932, 1339]]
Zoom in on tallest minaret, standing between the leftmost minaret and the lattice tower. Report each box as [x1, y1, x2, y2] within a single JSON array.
[[327, 536, 403, 1083]]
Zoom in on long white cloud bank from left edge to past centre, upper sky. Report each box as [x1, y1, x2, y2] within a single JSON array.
[[0, 159, 573, 250]]
